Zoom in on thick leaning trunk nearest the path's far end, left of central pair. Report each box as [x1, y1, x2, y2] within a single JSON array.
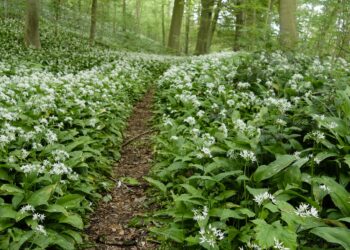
[[168, 0, 185, 52]]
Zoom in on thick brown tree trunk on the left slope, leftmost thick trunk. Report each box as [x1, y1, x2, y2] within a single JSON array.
[[24, 0, 41, 49]]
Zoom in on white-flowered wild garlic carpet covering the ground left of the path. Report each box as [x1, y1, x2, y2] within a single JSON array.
[[0, 20, 171, 249]]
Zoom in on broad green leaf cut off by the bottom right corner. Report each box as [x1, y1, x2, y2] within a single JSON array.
[[310, 227, 350, 249]]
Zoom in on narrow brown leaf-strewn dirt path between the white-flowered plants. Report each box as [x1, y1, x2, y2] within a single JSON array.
[[88, 91, 156, 250]]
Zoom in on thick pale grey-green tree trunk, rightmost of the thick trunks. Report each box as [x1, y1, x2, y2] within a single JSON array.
[[279, 0, 298, 50]]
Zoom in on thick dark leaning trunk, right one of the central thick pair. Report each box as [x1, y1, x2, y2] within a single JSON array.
[[196, 0, 214, 55]]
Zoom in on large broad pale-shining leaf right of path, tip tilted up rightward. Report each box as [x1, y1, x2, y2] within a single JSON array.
[[253, 155, 296, 182]]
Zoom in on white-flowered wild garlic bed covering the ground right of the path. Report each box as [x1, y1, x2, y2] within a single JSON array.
[[148, 52, 350, 249]]
